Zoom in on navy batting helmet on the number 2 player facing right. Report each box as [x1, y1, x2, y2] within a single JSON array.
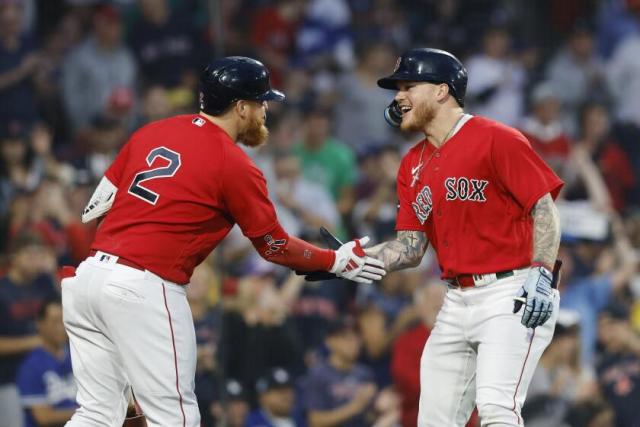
[[200, 56, 284, 116]]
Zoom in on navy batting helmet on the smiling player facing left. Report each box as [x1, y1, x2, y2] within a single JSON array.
[[378, 48, 467, 107]]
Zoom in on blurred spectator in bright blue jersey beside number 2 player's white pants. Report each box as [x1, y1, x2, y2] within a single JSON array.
[[16, 300, 77, 427]]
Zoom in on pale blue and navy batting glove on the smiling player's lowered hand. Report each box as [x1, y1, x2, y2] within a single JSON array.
[[513, 266, 553, 328]]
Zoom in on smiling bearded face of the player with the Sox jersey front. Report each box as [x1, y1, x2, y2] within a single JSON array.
[[395, 82, 449, 132]]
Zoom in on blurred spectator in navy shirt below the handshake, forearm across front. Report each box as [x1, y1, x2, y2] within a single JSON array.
[[305, 318, 377, 427]]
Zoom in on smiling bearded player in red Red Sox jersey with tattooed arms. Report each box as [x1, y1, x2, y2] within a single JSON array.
[[365, 49, 563, 427]]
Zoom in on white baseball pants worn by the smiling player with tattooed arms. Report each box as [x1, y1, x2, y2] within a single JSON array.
[[418, 269, 560, 427]]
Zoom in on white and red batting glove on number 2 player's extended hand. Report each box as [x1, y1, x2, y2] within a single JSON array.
[[329, 236, 387, 283]]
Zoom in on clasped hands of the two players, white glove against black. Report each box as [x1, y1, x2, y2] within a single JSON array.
[[296, 227, 387, 283]]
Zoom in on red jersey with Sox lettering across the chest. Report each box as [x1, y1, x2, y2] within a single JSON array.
[[396, 117, 563, 279]]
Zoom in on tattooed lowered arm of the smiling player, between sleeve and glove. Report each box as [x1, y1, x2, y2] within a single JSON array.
[[531, 194, 560, 268]]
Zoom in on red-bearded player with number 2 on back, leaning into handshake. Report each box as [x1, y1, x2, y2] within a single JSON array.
[[62, 57, 384, 427]]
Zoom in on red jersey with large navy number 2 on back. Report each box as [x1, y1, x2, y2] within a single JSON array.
[[92, 114, 277, 284]]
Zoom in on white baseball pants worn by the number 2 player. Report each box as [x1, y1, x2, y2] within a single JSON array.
[[62, 252, 200, 427]]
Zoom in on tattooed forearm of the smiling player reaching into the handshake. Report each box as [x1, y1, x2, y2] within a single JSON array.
[[364, 231, 429, 271]]
